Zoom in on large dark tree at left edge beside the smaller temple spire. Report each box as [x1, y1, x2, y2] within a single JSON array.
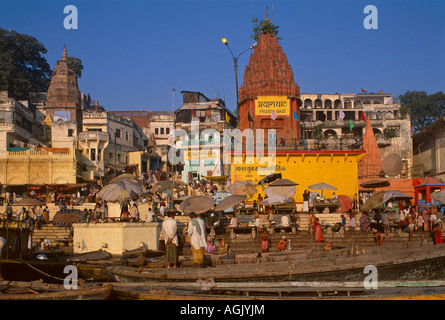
[[0, 28, 52, 100]]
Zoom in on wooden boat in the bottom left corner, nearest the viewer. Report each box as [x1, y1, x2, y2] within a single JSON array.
[[0, 281, 112, 300]]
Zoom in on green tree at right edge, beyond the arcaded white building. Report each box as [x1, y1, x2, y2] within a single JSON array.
[[399, 91, 445, 132]]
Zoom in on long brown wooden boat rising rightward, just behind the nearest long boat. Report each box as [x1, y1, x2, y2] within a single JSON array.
[[107, 244, 445, 282]]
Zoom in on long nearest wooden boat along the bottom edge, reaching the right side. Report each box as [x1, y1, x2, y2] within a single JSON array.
[[110, 281, 445, 300]]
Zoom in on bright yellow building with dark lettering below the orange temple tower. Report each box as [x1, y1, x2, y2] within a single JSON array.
[[226, 150, 365, 203]]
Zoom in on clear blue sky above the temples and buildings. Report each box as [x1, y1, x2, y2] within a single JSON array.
[[0, 0, 445, 111]]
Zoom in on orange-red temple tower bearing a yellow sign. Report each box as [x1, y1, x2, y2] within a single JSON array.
[[239, 17, 301, 147]]
